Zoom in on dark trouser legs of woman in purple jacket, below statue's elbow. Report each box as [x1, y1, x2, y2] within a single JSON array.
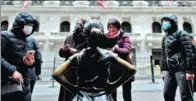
[[112, 80, 132, 101]]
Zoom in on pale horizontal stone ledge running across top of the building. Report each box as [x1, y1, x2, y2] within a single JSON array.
[[1, 5, 196, 14]]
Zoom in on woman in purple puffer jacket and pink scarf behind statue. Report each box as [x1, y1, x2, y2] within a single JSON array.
[[107, 18, 134, 101]]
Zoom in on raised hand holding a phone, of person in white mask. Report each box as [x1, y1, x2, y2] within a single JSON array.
[[23, 55, 35, 66]]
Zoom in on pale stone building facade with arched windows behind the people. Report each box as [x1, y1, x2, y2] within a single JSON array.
[[1, 0, 196, 63]]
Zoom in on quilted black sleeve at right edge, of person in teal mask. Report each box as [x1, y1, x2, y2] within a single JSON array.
[[180, 32, 193, 73]]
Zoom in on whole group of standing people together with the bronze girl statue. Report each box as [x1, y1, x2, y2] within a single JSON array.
[[1, 12, 196, 101]]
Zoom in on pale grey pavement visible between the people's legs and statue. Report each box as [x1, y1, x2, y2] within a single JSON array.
[[32, 80, 196, 101]]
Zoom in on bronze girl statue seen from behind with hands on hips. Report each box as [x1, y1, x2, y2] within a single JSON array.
[[52, 21, 136, 101]]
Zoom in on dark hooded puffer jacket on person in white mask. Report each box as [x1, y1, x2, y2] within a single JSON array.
[[1, 12, 39, 79]]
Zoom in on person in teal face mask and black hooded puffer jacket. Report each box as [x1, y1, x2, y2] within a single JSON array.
[[160, 14, 195, 101]]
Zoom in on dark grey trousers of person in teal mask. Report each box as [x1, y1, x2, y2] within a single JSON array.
[[163, 71, 194, 101]]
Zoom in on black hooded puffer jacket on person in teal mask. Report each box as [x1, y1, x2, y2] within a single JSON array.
[[161, 15, 193, 73]]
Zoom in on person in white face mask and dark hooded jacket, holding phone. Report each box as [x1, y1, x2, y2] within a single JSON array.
[[1, 12, 39, 101]]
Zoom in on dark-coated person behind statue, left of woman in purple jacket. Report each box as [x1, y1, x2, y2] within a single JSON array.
[[58, 19, 88, 101]]
